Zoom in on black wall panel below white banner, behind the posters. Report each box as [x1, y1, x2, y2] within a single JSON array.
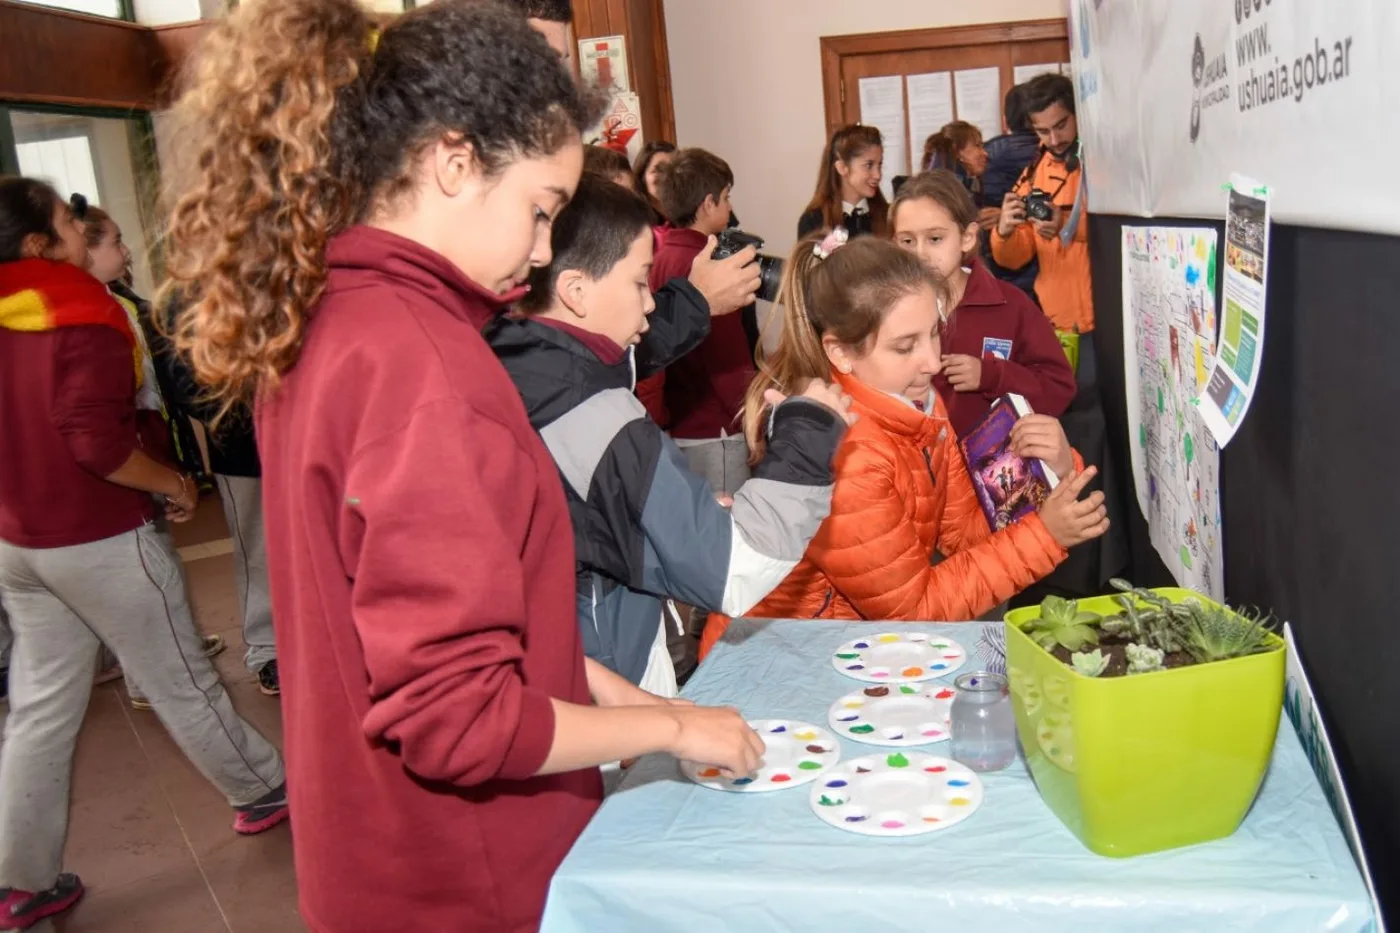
[[1089, 214, 1400, 916]]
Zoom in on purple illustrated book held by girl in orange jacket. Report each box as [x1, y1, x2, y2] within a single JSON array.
[[959, 395, 1060, 531]]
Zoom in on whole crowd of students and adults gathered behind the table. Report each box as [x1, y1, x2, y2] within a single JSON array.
[[0, 0, 1112, 933]]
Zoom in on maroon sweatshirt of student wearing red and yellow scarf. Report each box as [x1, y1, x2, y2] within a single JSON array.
[[0, 263, 155, 548]]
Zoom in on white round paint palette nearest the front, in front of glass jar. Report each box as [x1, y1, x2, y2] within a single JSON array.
[[811, 752, 981, 836]]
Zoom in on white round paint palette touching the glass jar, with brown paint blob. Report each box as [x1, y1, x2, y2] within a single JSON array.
[[826, 684, 956, 748]]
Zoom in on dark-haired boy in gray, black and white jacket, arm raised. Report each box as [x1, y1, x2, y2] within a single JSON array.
[[486, 174, 848, 695]]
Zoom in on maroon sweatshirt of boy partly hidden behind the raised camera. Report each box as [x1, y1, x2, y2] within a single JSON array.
[[651, 227, 755, 440]]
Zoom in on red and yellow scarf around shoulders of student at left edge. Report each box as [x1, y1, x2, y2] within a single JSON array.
[[0, 259, 143, 388]]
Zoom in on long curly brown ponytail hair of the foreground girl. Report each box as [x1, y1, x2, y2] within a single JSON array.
[[165, 0, 596, 410]]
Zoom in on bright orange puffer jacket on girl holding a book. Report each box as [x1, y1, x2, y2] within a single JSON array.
[[703, 374, 1084, 650]]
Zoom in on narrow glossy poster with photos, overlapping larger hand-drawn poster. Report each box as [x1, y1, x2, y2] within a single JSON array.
[[1201, 175, 1268, 447]]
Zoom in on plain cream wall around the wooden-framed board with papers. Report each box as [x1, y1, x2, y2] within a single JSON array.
[[665, 0, 1065, 255]]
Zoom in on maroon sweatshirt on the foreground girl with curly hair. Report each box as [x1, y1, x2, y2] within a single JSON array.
[[258, 227, 602, 933]]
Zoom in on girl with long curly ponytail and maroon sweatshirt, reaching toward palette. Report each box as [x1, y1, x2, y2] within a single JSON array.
[[169, 0, 763, 933]]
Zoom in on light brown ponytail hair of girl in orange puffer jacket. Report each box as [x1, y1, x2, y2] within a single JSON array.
[[743, 231, 948, 464]]
